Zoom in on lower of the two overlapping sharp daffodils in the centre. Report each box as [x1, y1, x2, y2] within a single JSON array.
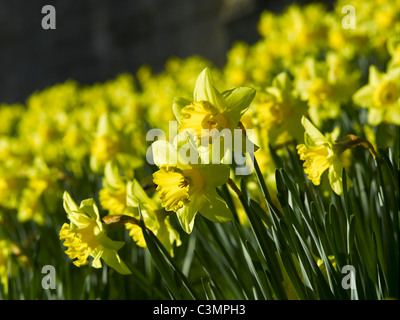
[[152, 140, 233, 233]]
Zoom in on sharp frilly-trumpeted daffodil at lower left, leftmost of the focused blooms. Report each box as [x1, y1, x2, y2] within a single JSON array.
[[60, 192, 131, 274]]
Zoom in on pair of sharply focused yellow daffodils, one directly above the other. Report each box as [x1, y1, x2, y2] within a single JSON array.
[[152, 68, 255, 233]]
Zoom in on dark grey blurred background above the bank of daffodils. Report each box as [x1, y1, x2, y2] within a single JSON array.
[[0, 0, 332, 103]]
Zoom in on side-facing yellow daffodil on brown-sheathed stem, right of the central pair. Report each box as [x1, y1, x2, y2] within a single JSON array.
[[297, 117, 351, 195]]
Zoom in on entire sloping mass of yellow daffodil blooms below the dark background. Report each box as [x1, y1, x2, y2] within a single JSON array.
[[0, 0, 400, 291]]
